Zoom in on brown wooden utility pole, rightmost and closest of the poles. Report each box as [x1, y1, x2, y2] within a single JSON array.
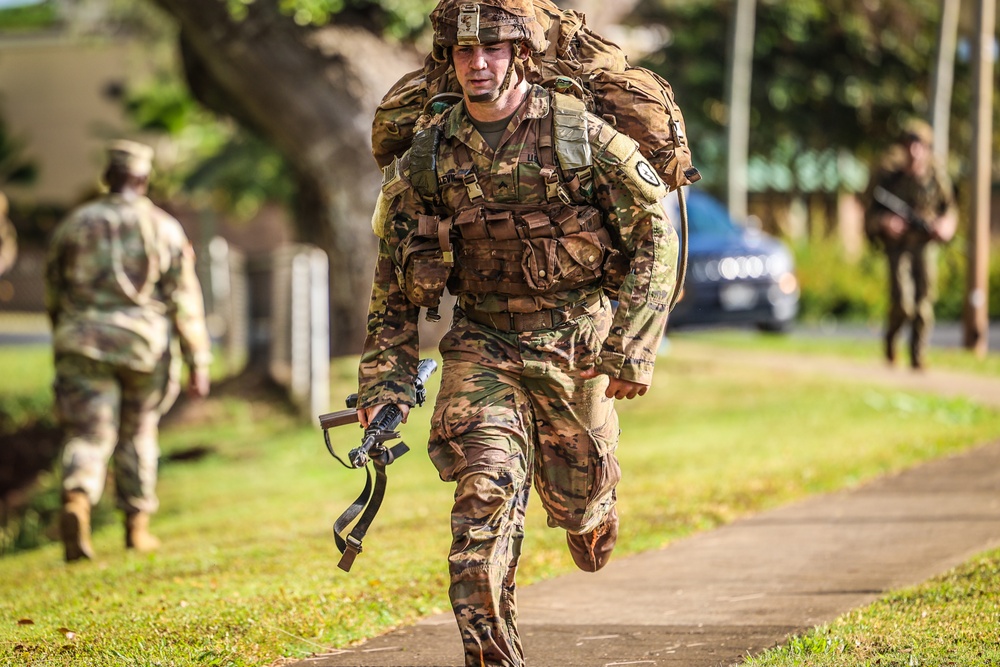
[[962, 0, 996, 357]]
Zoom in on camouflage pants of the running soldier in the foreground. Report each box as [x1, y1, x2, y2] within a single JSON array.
[[429, 310, 621, 667]]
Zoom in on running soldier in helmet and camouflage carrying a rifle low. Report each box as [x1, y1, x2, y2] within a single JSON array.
[[358, 0, 678, 666]]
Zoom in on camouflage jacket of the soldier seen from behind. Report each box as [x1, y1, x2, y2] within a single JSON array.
[[45, 194, 211, 372]]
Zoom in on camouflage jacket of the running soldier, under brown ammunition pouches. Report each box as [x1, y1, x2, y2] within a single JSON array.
[[359, 86, 678, 407]]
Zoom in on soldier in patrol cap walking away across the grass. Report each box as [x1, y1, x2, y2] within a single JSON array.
[[46, 141, 211, 561]]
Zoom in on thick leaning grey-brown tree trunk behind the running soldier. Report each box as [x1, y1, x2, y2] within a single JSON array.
[[147, 0, 420, 356]]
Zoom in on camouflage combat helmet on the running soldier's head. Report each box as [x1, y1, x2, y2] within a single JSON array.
[[431, 0, 546, 62]]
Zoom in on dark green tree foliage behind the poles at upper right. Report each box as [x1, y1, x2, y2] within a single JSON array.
[[637, 0, 969, 192]]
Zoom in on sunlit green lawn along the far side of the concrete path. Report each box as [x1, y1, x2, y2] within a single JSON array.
[[0, 337, 1000, 667]]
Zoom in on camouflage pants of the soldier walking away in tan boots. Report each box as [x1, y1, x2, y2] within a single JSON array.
[[55, 354, 178, 512]]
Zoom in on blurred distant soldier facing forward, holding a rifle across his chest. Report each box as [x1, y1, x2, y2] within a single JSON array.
[[865, 121, 958, 370]]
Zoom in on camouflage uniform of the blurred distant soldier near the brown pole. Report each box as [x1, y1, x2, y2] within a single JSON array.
[[866, 144, 955, 368]]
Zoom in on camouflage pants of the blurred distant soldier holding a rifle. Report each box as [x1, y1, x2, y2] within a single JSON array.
[[885, 244, 937, 365]]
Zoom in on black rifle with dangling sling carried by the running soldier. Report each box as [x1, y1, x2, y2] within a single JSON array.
[[319, 359, 437, 572]]
